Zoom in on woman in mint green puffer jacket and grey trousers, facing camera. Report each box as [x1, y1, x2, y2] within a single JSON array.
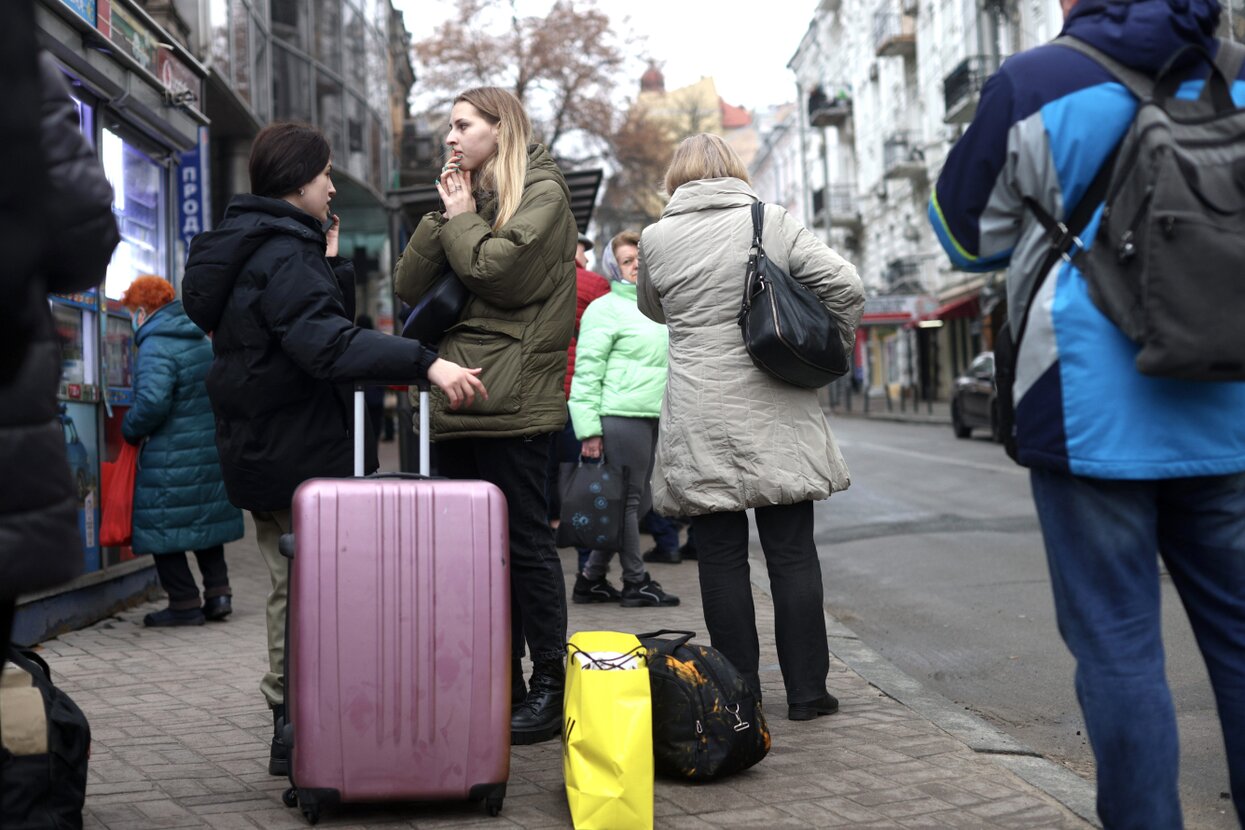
[[569, 230, 679, 609]]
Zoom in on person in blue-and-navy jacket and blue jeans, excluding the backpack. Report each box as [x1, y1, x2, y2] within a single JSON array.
[[930, 0, 1245, 828]]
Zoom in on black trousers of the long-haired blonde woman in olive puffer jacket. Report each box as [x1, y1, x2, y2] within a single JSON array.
[[435, 433, 566, 663]]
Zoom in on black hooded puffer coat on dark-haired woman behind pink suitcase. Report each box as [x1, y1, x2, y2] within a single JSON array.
[[182, 194, 437, 510]]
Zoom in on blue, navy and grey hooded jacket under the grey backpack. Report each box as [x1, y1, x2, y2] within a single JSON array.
[[929, 0, 1245, 479]]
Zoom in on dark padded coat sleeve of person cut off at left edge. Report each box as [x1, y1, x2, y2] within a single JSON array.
[[39, 51, 121, 291]]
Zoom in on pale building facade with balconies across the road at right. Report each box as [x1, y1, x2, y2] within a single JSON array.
[[788, 0, 1062, 401]]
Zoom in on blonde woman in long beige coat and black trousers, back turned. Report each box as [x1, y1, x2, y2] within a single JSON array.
[[639, 133, 864, 720]]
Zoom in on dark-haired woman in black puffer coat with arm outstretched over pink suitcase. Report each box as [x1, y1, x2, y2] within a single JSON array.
[[182, 123, 487, 775]]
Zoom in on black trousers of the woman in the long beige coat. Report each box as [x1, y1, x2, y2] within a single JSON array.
[[692, 501, 830, 704]]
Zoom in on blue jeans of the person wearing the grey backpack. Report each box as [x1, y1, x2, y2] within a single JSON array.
[[1030, 469, 1245, 829]]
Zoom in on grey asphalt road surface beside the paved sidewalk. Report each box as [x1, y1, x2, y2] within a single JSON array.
[[817, 418, 1239, 830]]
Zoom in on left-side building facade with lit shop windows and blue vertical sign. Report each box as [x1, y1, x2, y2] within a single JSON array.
[[14, 0, 415, 642]]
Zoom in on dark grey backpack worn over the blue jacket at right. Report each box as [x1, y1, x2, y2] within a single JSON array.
[[1055, 37, 1245, 381]]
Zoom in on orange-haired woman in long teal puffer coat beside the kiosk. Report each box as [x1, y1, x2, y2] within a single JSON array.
[[121, 274, 244, 627]]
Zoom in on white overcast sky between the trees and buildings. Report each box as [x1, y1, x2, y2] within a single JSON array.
[[393, 0, 817, 111]]
